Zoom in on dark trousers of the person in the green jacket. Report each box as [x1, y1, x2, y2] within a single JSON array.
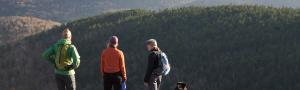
[[55, 74, 76, 90]]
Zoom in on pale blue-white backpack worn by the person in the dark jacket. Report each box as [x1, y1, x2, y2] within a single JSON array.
[[157, 52, 171, 76]]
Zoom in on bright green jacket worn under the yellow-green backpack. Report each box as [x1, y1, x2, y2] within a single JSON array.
[[42, 39, 80, 75]]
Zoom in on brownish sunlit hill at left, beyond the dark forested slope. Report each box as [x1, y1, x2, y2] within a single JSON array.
[[0, 16, 60, 46]]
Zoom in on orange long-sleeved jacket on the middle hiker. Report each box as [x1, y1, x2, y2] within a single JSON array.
[[100, 48, 127, 80]]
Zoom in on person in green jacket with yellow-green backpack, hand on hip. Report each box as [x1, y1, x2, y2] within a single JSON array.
[[42, 28, 80, 90]]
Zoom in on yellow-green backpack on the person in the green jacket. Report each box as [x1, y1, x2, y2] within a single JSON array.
[[55, 44, 73, 70]]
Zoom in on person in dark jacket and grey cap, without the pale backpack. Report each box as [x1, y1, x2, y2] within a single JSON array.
[[144, 39, 162, 90]]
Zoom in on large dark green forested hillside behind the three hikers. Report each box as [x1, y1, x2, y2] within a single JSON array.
[[0, 6, 300, 90]]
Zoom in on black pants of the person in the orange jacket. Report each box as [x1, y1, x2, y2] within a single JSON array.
[[103, 72, 122, 90]]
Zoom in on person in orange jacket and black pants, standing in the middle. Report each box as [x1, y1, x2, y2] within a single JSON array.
[[100, 36, 127, 90]]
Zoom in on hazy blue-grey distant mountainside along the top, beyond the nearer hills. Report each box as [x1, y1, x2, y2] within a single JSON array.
[[0, 0, 300, 22]]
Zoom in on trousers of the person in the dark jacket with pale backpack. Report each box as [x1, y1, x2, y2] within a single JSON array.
[[147, 75, 162, 90]]
